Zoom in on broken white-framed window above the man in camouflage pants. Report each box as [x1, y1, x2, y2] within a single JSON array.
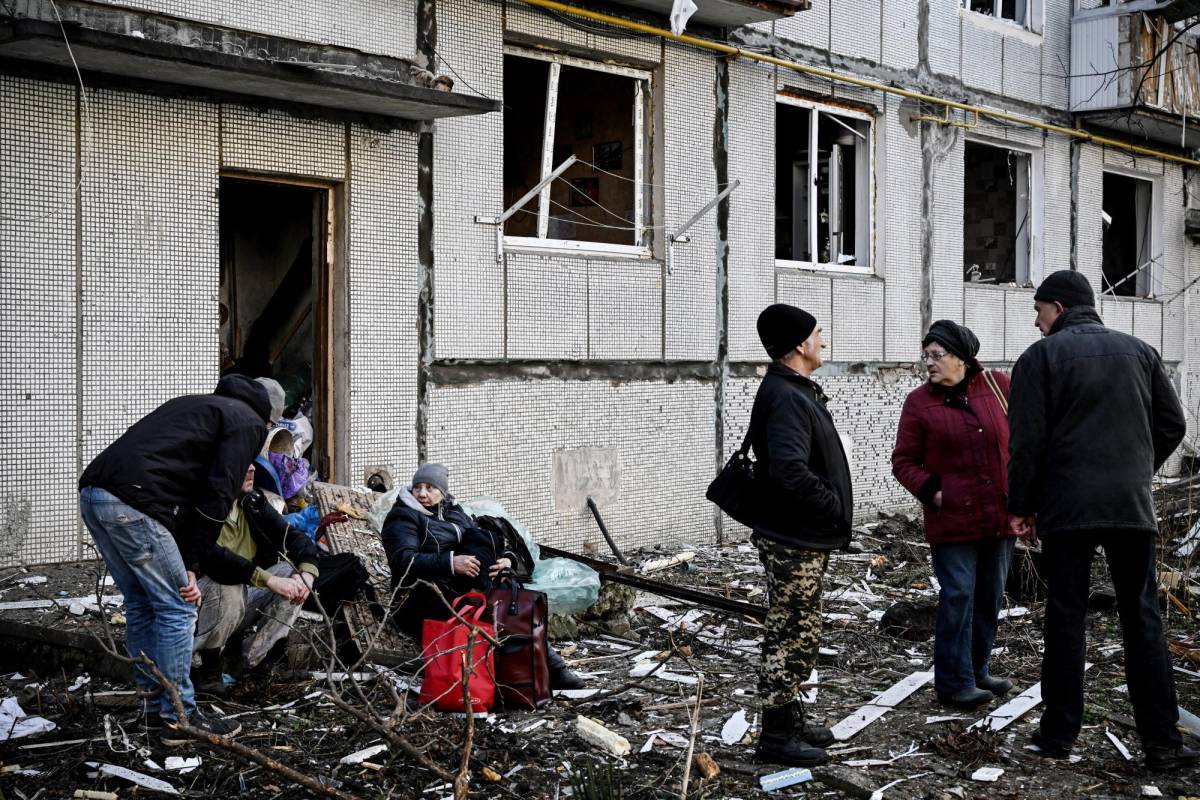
[[775, 97, 871, 271]]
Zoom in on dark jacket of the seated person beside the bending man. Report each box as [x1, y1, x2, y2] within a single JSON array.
[[200, 489, 320, 585]]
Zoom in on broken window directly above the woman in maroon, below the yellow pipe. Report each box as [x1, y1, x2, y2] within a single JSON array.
[[962, 142, 1032, 285]]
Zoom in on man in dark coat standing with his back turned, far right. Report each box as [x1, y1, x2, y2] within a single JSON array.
[[1008, 270, 1200, 769]]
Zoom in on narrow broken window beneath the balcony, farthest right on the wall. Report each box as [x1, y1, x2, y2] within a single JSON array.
[[1100, 173, 1154, 297]]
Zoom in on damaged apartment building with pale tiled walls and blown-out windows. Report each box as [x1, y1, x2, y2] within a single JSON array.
[[0, 0, 1200, 563]]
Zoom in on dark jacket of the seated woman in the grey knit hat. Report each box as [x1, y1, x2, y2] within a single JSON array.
[[382, 489, 475, 585]]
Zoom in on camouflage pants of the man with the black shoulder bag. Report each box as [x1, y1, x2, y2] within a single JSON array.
[[754, 536, 829, 705]]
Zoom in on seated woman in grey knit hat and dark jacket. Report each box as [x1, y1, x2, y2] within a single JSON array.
[[383, 464, 583, 688]]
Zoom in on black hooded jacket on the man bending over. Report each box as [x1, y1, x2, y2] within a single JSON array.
[[79, 375, 271, 572]]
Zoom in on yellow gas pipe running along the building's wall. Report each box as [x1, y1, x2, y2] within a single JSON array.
[[521, 0, 1200, 167]]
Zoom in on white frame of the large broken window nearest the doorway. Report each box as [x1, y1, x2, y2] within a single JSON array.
[[502, 44, 654, 259]]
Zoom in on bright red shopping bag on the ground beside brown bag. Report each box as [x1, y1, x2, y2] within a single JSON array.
[[420, 591, 496, 711]]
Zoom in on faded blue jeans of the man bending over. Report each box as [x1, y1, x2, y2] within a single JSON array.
[[79, 487, 196, 721]]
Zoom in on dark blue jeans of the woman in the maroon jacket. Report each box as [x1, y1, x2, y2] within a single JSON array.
[[930, 536, 1016, 696]]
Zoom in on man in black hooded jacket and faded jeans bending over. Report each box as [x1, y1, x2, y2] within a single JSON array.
[[79, 375, 271, 735]]
